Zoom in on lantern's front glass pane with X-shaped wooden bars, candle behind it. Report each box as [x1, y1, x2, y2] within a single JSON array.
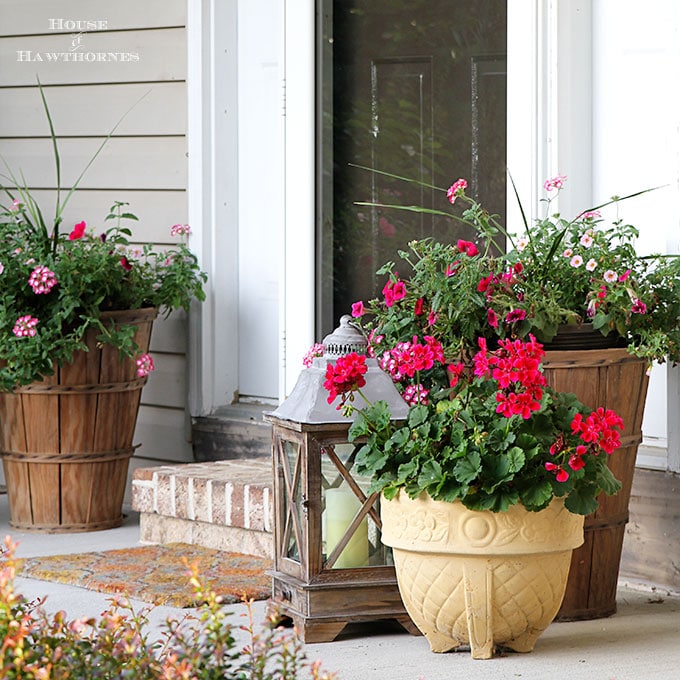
[[321, 442, 393, 569]]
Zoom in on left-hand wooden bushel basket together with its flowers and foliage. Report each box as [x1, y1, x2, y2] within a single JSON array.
[[0, 83, 206, 531]]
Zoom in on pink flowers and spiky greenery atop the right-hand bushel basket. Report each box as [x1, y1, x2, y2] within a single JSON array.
[[353, 176, 680, 362]]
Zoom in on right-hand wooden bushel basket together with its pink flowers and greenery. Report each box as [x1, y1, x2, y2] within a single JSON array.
[[353, 171, 680, 620]]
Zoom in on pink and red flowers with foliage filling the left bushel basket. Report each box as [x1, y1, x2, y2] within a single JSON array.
[[0, 87, 206, 390]]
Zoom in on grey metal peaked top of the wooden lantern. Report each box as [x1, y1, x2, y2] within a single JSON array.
[[268, 315, 408, 424]]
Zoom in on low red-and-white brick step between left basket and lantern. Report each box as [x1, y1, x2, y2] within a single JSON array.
[[132, 458, 273, 557]]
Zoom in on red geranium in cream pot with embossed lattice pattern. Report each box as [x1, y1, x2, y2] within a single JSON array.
[[325, 335, 623, 658]]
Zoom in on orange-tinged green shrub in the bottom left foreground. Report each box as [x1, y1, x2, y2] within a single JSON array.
[[0, 538, 335, 680]]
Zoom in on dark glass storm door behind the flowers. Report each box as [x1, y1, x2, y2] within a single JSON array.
[[317, 0, 506, 337]]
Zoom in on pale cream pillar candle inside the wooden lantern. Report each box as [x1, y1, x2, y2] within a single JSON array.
[[323, 489, 368, 569]]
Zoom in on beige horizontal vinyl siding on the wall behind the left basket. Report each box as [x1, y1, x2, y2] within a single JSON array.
[[0, 0, 192, 465]]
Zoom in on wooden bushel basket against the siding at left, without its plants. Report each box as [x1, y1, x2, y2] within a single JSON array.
[[0, 308, 156, 532]]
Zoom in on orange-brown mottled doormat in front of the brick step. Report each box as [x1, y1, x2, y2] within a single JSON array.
[[17, 543, 273, 608]]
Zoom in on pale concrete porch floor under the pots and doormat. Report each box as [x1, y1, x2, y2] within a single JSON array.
[[5, 495, 680, 680]]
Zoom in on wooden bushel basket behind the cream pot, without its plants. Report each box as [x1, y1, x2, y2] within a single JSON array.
[[543, 348, 649, 621]]
